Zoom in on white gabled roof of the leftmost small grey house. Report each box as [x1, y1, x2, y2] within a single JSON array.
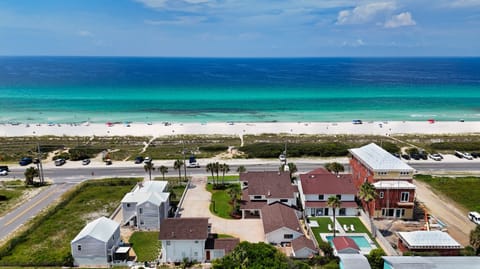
[[72, 217, 120, 243]]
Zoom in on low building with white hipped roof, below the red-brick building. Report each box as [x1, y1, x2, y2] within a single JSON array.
[[397, 231, 463, 256]]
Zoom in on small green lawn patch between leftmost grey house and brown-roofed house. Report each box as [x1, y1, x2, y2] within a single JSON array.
[[129, 232, 160, 262]]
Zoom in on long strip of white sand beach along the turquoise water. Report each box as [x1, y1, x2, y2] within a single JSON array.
[[0, 121, 480, 137]]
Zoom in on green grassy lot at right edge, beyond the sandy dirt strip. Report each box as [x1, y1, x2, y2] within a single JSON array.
[[415, 175, 480, 211]]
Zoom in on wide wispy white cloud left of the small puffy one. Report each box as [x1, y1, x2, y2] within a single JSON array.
[[337, 2, 395, 24]]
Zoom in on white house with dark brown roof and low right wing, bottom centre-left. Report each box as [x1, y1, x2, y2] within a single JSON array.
[[159, 218, 240, 263]]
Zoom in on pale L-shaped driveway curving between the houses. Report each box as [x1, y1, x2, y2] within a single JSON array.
[[180, 176, 265, 243]]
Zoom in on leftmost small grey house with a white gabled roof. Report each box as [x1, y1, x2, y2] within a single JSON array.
[[70, 217, 120, 267]]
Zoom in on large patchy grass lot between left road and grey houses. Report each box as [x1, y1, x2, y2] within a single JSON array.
[[0, 178, 139, 266]]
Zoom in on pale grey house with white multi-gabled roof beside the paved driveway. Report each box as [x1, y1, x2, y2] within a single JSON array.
[[121, 181, 170, 230]]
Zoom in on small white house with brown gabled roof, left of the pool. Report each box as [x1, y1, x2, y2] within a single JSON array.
[[262, 203, 303, 244]]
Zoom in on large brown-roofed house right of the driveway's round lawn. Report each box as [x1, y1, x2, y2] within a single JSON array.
[[240, 171, 298, 218]]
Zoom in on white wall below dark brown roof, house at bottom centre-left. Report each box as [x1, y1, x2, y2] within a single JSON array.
[[162, 240, 205, 262]]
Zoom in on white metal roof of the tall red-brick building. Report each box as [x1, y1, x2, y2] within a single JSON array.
[[348, 143, 414, 172]]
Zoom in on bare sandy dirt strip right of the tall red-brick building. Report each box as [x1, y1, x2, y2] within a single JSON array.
[[414, 180, 475, 246]]
